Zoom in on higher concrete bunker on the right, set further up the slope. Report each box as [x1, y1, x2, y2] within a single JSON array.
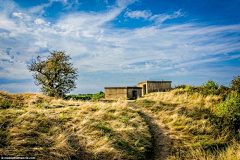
[[138, 81, 172, 95]]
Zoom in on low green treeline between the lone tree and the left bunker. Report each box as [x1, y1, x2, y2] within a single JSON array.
[[64, 91, 105, 101]]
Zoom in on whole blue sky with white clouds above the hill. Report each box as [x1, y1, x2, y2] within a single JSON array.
[[0, 0, 240, 94]]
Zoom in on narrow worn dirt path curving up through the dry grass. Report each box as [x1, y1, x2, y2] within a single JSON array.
[[128, 102, 171, 160]]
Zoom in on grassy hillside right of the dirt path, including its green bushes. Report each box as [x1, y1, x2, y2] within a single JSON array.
[[137, 88, 240, 160]]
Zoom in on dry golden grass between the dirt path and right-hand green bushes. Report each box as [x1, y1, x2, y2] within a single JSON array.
[[137, 89, 240, 160]]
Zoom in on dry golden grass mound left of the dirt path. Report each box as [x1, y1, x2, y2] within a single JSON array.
[[0, 92, 151, 159]]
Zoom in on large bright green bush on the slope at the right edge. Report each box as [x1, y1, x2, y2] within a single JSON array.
[[216, 91, 240, 132]]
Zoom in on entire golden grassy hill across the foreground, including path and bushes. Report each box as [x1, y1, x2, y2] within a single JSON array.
[[0, 87, 240, 160]]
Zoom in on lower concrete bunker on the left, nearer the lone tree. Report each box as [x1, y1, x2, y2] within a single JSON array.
[[104, 87, 142, 99]]
